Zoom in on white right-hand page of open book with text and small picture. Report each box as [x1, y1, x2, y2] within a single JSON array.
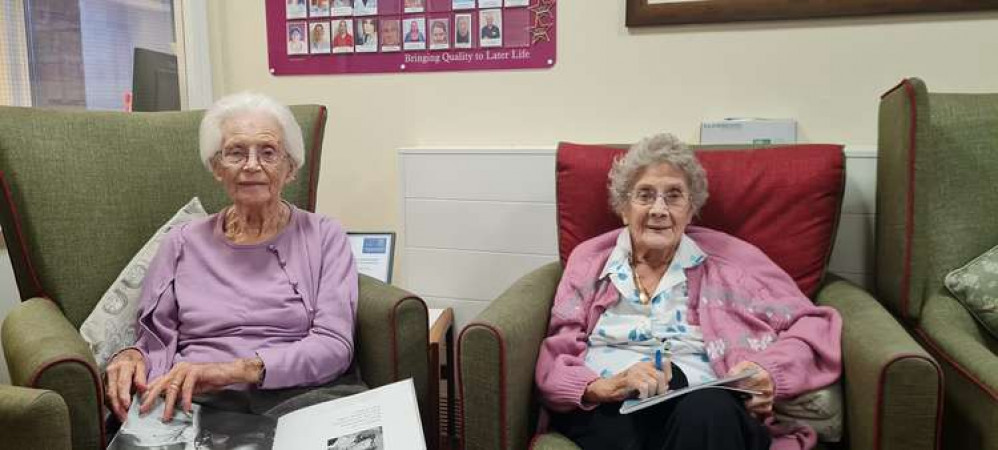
[[274, 379, 426, 450]]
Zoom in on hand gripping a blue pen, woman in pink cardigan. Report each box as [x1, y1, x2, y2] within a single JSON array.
[[582, 362, 672, 403]]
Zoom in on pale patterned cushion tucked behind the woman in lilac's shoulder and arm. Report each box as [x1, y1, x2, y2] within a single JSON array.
[[80, 197, 208, 370]]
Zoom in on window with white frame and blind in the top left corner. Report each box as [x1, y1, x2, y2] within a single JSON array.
[[0, 0, 210, 111]]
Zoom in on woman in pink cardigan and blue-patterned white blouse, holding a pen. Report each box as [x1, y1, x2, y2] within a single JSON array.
[[536, 134, 842, 450]]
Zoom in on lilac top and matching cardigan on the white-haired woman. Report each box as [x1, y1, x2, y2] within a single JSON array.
[[134, 207, 358, 389]]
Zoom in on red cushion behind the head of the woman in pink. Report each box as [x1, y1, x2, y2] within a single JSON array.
[[557, 143, 845, 297]]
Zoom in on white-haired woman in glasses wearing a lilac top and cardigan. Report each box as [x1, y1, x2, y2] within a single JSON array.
[[106, 93, 359, 428]]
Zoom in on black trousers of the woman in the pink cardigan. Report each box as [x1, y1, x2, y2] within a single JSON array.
[[551, 366, 770, 450]]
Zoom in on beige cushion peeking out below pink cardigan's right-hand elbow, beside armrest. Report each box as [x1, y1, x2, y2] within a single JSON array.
[[774, 382, 844, 442]]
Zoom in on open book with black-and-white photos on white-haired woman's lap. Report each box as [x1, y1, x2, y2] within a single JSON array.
[[108, 379, 426, 450]]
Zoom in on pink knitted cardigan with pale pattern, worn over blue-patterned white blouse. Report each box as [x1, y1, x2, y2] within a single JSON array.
[[536, 226, 842, 449]]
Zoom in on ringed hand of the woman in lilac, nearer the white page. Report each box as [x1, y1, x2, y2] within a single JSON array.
[[139, 357, 263, 422]]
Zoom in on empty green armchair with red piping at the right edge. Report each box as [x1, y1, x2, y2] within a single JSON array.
[[876, 78, 998, 449]]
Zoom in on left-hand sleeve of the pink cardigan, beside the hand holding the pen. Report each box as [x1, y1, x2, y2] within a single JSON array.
[[535, 251, 599, 412]]
